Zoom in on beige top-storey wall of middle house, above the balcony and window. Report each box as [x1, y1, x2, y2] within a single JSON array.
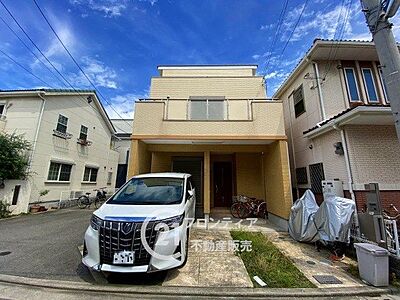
[[150, 76, 266, 99]]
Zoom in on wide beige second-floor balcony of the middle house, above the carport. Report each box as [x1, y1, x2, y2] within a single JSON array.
[[133, 99, 285, 140]]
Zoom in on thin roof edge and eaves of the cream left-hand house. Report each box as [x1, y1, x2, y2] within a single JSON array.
[[0, 88, 116, 134]]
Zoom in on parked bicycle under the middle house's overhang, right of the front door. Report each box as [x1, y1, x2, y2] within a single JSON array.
[[231, 195, 267, 219]]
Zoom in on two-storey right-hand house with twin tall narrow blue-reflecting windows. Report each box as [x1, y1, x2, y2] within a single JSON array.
[[274, 39, 400, 210]]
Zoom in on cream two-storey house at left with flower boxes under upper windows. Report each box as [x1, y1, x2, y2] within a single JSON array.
[[0, 89, 118, 213]]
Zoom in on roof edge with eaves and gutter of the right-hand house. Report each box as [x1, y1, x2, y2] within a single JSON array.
[[273, 38, 399, 98]]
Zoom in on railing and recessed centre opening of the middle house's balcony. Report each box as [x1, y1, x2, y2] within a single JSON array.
[[139, 98, 278, 122]]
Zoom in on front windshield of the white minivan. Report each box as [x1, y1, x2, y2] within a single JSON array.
[[107, 177, 183, 205]]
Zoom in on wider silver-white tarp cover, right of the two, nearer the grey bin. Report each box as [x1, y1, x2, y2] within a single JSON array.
[[314, 196, 356, 243]]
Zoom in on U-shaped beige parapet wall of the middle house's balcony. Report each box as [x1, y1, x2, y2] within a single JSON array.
[[133, 101, 285, 138]]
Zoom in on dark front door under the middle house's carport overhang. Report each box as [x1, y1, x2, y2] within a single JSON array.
[[213, 161, 232, 207]]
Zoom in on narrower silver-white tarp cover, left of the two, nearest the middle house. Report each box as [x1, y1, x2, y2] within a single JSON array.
[[289, 190, 318, 242]]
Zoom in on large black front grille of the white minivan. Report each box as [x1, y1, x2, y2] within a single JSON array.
[[99, 221, 157, 266]]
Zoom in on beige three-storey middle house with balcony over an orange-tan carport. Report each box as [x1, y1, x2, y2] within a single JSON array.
[[128, 65, 292, 226]]
